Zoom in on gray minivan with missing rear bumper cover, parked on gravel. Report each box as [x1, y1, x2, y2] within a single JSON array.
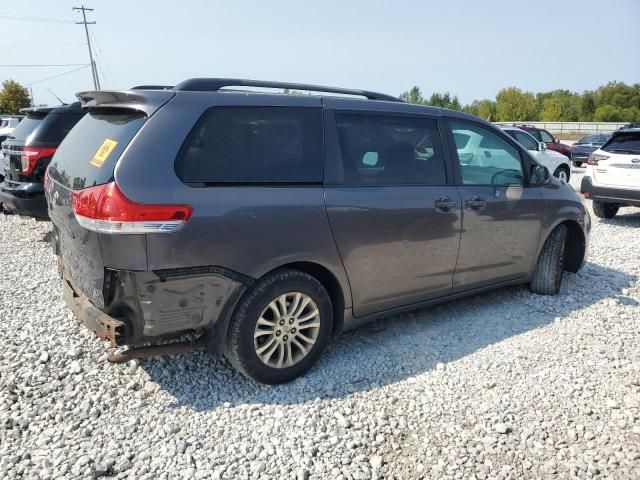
[[45, 79, 591, 384]]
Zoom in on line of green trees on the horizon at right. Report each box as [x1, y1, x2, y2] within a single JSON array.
[[400, 82, 640, 122]]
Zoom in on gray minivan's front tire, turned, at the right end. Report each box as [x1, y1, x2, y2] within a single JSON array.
[[529, 225, 567, 295]]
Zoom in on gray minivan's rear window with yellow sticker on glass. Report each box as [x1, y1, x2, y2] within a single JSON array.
[[49, 109, 147, 190]]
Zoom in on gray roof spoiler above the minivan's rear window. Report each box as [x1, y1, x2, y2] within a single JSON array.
[[76, 89, 176, 116]]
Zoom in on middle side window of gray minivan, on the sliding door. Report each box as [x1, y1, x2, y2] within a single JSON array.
[[336, 113, 447, 185]]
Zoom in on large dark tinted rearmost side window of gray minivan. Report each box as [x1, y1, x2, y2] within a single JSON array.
[[175, 107, 323, 184]]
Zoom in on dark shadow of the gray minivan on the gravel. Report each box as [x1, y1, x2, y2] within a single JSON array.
[[141, 263, 637, 410]]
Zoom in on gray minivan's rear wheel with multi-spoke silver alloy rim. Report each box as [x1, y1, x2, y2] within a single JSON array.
[[225, 270, 333, 385]]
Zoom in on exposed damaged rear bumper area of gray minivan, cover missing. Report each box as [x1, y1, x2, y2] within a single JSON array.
[[60, 262, 251, 346]]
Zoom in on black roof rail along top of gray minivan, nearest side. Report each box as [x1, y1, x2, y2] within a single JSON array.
[[173, 78, 402, 102]]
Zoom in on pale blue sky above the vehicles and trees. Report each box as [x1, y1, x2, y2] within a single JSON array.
[[0, 0, 640, 104]]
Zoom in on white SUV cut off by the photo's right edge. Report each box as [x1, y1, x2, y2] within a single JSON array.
[[580, 128, 640, 218]]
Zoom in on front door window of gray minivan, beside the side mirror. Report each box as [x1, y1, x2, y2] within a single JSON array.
[[450, 122, 524, 185]]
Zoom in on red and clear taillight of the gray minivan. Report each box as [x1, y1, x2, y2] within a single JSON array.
[[72, 182, 193, 233]]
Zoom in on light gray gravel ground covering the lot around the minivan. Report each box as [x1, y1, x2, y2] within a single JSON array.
[[0, 170, 640, 480]]
